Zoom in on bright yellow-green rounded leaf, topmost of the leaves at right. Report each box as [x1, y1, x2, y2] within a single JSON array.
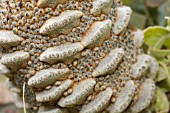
[[144, 26, 170, 48]]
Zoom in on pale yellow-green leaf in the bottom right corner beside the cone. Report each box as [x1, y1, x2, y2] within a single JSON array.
[[155, 88, 169, 113]]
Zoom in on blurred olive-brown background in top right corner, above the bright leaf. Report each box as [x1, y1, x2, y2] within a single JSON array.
[[122, 0, 170, 29]]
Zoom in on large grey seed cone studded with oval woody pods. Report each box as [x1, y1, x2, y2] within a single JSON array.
[[0, 0, 158, 113]]
